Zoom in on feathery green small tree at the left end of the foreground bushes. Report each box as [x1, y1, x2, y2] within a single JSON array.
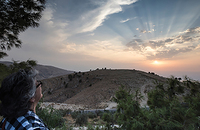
[[113, 86, 144, 130]]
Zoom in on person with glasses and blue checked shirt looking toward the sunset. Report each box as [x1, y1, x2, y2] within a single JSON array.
[[0, 68, 48, 130]]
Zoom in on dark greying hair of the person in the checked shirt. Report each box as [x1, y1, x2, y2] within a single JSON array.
[[0, 68, 38, 119]]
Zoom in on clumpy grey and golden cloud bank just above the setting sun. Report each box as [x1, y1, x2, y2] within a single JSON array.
[[126, 27, 200, 60]]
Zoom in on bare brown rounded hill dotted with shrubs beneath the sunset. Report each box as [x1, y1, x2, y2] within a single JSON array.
[[42, 69, 166, 108]]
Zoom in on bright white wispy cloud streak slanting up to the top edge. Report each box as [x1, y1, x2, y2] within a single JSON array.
[[61, 0, 137, 33]]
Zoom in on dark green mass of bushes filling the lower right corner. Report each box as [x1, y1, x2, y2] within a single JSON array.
[[111, 77, 200, 130]]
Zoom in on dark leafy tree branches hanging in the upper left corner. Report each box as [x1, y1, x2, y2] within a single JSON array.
[[0, 0, 46, 59]]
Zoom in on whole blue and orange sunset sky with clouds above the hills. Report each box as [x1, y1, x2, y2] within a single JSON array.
[[1, 0, 200, 81]]
